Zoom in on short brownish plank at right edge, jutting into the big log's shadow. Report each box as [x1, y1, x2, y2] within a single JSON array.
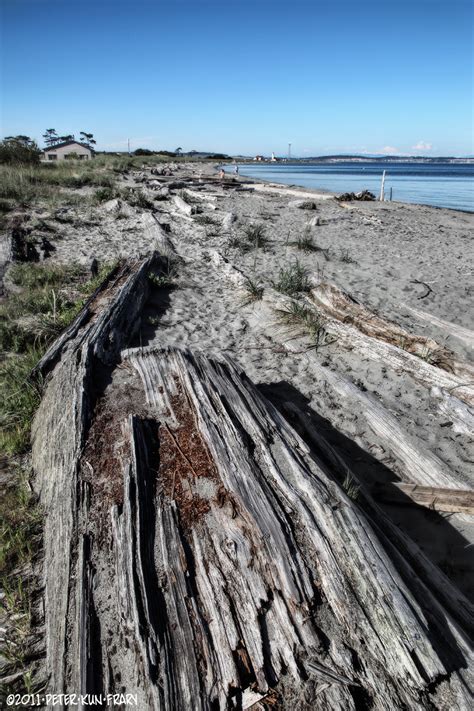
[[372, 482, 474, 515]]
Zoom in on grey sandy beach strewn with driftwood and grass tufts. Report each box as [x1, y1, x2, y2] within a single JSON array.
[[8, 164, 474, 594]]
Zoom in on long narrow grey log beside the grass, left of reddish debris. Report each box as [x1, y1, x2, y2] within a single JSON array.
[[32, 255, 157, 691]]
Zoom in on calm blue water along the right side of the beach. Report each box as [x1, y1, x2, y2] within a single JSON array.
[[226, 162, 474, 212]]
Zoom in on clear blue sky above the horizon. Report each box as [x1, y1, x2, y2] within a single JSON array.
[[0, 0, 474, 156]]
